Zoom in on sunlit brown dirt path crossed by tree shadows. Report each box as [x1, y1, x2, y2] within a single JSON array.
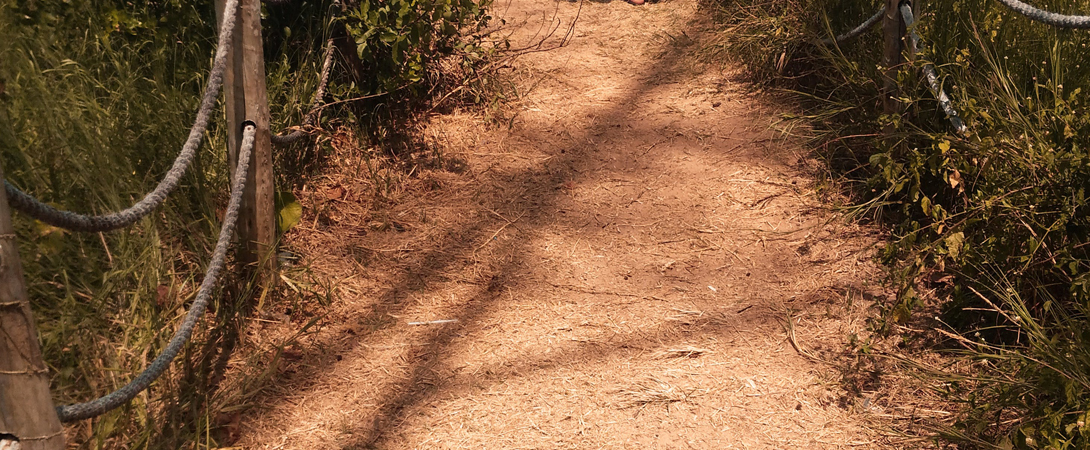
[[237, 0, 894, 449]]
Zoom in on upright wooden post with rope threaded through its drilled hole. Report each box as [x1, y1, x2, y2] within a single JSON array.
[[216, 0, 277, 288]]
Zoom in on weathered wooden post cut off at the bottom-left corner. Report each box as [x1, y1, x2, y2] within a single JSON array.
[[0, 163, 64, 450]]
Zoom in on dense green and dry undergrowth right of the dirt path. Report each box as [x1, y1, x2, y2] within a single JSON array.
[[707, 0, 1090, 449]]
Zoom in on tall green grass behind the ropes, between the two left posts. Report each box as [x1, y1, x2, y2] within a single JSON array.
[[0, 1, 236, 448]]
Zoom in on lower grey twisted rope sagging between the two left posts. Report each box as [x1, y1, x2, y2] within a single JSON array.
[[57, 125, 255, 422]]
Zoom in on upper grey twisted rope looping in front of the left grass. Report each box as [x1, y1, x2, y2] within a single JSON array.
[[4, 0, 239, 232]]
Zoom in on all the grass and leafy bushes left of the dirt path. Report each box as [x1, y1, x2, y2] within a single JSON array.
[[0, 0, 491, 449]]
